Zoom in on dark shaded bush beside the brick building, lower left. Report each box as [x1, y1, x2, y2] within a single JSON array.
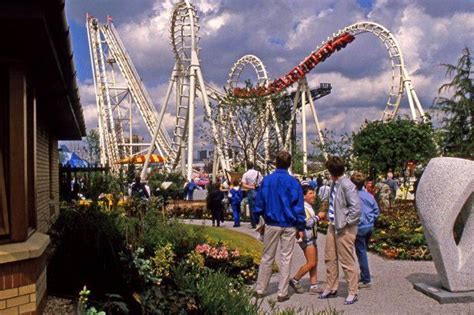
[[48, 205, 125, 296]]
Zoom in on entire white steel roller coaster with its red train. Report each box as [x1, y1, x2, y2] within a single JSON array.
[[87, 0, 424, 179]]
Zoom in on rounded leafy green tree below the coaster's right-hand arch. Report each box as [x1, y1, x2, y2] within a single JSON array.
[[352, 118, 436, 176]]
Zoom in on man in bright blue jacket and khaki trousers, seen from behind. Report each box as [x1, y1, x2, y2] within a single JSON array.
[[254, 151, 305, 302]]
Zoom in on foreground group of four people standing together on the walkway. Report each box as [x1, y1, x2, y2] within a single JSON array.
[[252, 151, 380, 305]]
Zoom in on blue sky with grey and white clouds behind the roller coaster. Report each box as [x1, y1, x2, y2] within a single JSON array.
[[66, 0, 474, 154]]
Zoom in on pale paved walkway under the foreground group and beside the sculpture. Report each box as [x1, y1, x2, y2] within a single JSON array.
[[186, 220, 474, 315]]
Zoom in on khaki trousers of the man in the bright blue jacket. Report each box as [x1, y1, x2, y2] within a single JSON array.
[[256, 225, 296, 296]]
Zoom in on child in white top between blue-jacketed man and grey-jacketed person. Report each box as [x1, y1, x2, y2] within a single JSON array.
[[290, 185, 326, 294]]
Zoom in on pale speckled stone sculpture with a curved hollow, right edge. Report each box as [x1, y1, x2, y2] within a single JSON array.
[[416, 158, 474, 292]]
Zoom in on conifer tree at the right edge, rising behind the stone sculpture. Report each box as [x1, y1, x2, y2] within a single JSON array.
[[433, 47, 474, 159]]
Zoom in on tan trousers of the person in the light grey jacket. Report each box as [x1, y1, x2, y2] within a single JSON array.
[[324, 224, 359, 294]]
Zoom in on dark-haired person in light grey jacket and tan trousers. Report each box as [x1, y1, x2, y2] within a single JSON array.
[[319, 157, 360, 305]]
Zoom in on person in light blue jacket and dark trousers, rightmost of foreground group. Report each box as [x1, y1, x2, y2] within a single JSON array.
[[351, 172, 380, 289]]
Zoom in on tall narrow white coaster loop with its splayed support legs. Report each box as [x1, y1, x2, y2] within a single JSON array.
[[142, 0, 229, 180]]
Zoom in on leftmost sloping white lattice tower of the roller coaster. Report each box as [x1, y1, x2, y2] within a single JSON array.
[[86, 16, 171, 169]]
